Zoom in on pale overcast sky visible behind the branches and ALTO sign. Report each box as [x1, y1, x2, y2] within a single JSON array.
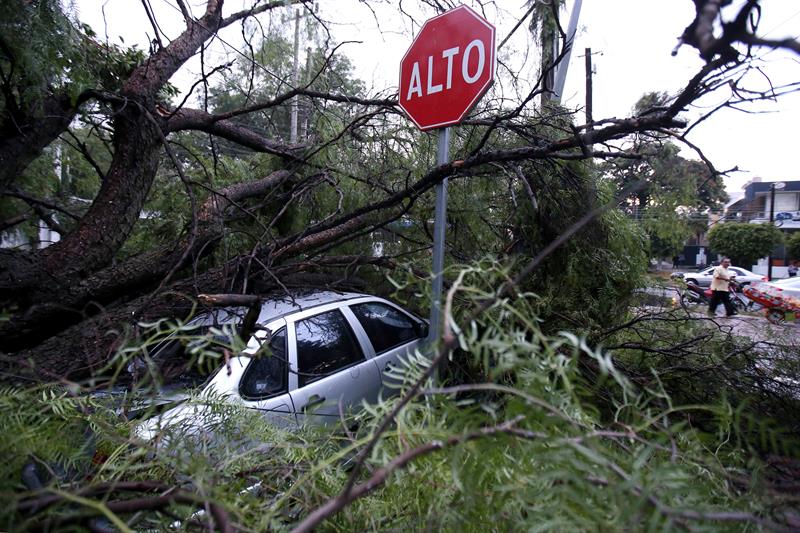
[[74, 0, 800, 192]]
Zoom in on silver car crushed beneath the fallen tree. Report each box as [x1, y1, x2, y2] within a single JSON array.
[[136, 291, 428, 440]]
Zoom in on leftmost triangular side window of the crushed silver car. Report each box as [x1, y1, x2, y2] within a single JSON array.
[[239, 328, 288, 400]]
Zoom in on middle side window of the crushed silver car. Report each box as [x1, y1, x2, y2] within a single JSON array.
[[295, 309, 365, 387]]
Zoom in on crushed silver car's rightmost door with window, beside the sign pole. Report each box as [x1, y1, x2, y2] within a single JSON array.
[[348, 300, 427, 395]]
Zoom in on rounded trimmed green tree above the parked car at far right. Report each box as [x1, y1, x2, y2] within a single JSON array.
[[708, 222, 783, 268]]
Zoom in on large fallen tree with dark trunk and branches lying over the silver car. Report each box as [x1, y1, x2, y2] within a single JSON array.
[[0, 0, 797, 379]]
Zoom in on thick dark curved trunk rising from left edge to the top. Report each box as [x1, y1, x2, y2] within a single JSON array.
[[0, 0, 228, 336]]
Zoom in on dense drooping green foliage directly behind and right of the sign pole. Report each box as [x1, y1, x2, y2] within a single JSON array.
[[362, 111, 647, 332]]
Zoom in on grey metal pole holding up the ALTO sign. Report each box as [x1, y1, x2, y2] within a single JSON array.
[[428, 128, 450, 342]]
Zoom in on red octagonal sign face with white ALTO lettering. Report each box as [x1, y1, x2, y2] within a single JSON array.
[[400, 6, 495, 131]]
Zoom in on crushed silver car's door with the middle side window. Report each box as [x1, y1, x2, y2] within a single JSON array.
[[287, 306, 381, 425]]
